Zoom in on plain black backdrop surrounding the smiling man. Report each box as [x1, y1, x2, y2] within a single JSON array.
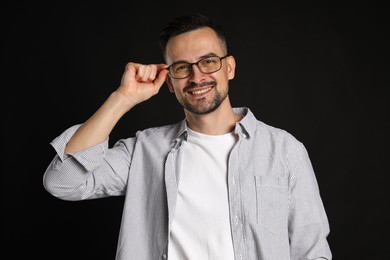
[[1, 0, 390, 260]]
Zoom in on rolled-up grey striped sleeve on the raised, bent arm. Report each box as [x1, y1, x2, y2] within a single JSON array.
[[43, 125, 134, 200]]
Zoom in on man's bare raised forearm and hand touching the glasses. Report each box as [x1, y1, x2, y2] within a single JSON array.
[[65, 62, 168, 153]]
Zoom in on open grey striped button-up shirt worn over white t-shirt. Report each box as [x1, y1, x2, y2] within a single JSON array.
[[43, 107, 332, 260]]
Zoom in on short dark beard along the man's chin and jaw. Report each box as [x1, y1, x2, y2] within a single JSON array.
[[181, 82, 228, 115]]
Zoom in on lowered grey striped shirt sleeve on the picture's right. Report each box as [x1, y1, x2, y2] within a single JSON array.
[[289, 143, 332, 260]]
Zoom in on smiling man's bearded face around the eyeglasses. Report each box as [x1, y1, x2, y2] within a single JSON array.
[[166, 28, 235, 115]]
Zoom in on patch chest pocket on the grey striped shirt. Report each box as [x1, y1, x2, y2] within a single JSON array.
[[255, 176, 288, 234]]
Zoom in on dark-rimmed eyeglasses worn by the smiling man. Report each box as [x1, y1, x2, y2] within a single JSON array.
[[168, 55, 229, 79]]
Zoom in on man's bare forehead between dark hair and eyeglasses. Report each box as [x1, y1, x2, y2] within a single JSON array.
[[166, 27, 224, 64]]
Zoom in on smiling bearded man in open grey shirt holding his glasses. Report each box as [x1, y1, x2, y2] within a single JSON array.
[[44, 14, 332, 260]]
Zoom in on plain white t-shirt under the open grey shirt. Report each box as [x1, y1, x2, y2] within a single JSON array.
[[168, 129, 237, 260]]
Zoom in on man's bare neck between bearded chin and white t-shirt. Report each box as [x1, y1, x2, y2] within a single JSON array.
[[185, 98, 242, 135]]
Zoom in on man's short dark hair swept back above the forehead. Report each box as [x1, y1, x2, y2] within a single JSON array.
[[159, 13, 227, 58]]
